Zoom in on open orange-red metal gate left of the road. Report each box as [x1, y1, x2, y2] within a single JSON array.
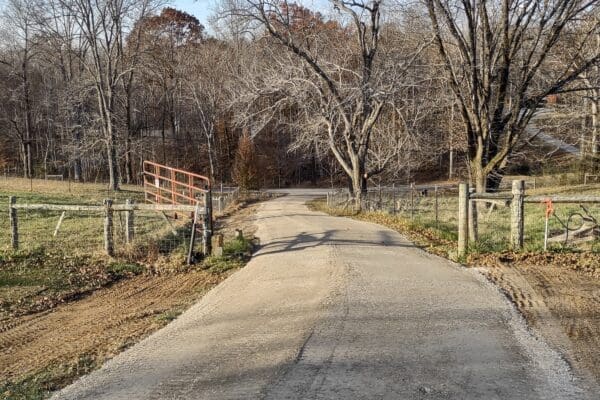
[[144, 161, 210, 205]]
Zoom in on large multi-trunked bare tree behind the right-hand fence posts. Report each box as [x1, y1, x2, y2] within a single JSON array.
[[425, 0, 600, 192]]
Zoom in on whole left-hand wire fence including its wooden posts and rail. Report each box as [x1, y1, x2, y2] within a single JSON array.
[[0, 192, 212, 263]]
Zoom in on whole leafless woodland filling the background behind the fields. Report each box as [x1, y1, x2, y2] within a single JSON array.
[[0, 0, 600, 204]]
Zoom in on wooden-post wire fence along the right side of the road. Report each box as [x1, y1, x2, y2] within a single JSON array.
[[327, 180, 600, 256]]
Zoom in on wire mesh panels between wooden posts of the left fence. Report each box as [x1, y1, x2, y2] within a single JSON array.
[[0, 196, 193, 256]]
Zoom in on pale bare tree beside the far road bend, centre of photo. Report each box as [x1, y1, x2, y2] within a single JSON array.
[[224, 0, 426, 209]]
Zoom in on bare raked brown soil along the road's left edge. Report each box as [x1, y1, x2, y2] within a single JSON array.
[[0, 200, 259, 398]]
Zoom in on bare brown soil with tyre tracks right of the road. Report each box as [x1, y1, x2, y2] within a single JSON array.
[[469, 253, 600, 384]]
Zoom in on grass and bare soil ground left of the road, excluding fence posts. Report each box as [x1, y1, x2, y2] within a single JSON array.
[[0, 179, 256, 400]]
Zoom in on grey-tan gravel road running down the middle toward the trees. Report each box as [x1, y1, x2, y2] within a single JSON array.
[[54, 192, 593, 400]]
